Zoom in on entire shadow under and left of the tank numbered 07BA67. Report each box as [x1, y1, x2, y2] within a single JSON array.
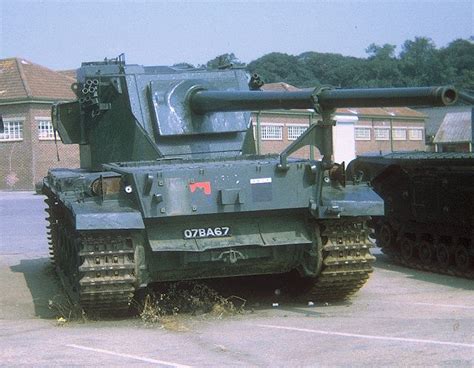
[[10, 258, 358, 320]]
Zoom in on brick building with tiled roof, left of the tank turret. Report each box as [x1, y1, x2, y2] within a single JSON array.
[[0, 58, 79, 190]]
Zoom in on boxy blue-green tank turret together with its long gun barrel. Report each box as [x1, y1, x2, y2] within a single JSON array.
[[53, 54, 457, 170]]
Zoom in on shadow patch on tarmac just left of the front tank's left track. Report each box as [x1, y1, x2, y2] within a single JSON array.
[[10, 258, 67, 319]]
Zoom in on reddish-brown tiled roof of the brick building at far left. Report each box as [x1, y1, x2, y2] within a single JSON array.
[[0, 58, 76, 101]]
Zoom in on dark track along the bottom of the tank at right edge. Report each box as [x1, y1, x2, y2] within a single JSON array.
[[376, 223, 474, 279]]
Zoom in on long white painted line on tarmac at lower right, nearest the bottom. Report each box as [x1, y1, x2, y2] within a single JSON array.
[[255, 324, 474, 348]]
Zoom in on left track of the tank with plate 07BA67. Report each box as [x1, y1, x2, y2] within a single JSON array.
[[46, 191, 136, 315]]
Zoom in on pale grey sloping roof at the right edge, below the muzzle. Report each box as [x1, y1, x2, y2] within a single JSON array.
[[433, 112, 472, 143]]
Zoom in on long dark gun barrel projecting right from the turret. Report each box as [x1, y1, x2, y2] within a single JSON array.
[[189, 87, 458, 114]]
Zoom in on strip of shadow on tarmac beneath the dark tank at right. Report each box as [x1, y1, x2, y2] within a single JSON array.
[[374, 253, 474, 290]]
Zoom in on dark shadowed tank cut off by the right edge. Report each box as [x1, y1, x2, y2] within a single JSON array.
[[350, 152, 474, 279]]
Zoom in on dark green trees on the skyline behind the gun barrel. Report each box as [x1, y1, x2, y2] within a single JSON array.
[[226, 37, 474, 90]]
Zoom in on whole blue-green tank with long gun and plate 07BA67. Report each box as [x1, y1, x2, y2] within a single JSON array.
[[42, 58, 456, 314]]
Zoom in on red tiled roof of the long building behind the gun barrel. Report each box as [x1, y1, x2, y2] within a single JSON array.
[[262, 82, 426, 119]]
